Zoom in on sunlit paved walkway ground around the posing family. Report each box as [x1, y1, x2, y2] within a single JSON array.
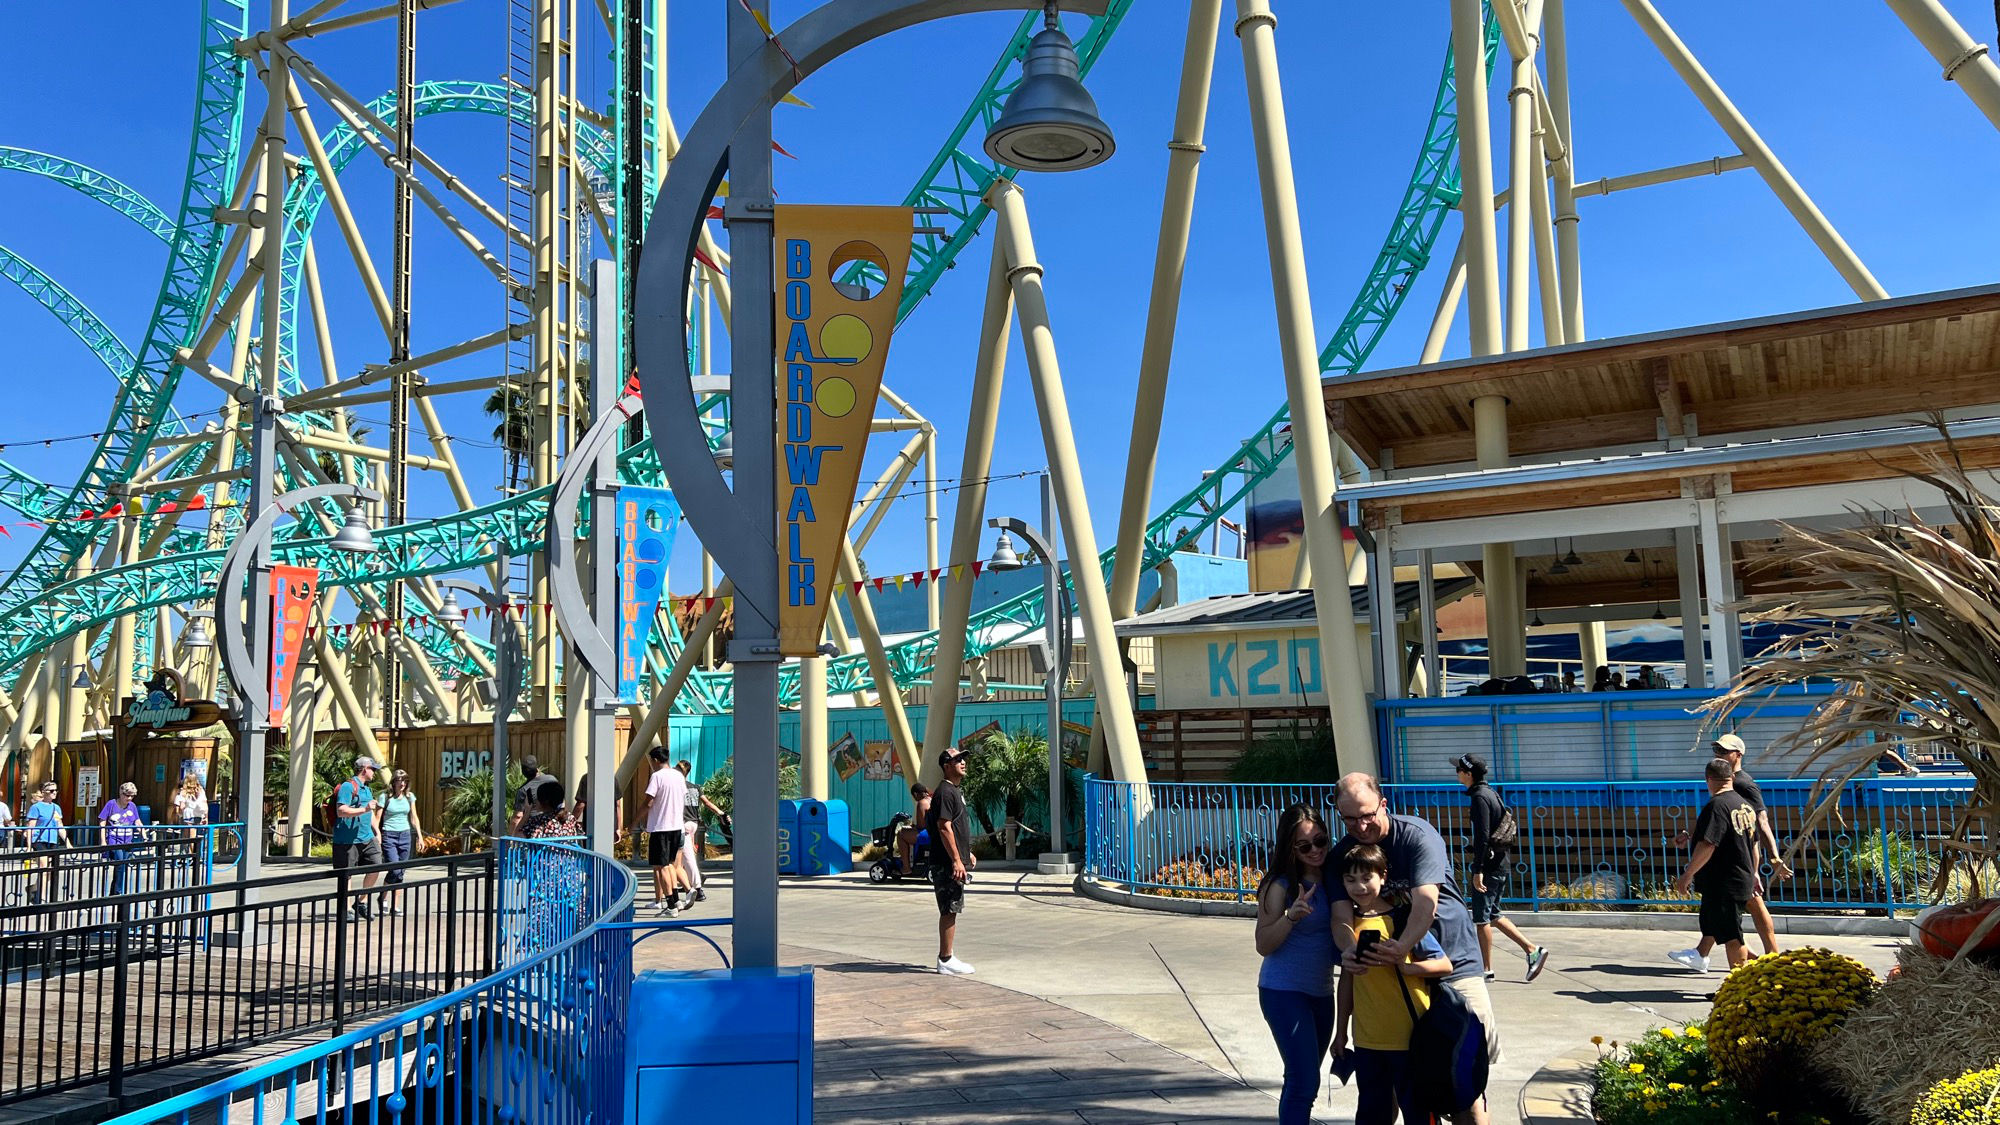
[[656, 871, 1894, 1125]]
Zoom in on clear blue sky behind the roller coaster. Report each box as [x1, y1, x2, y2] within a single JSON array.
[[0, 0, 2000, 593]]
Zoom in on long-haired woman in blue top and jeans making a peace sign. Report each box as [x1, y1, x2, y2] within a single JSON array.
[[1256, 805, 1338, 1125]]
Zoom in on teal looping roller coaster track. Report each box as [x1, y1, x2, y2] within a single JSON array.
[[0, 0, 1498, 711]]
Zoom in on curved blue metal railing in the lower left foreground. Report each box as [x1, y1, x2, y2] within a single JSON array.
[[112, 841, 634, 1125]]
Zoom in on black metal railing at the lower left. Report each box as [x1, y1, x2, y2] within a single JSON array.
[[0, 841, 498, 1103]]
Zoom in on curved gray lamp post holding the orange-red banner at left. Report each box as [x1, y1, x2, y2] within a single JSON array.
[[216, 482, 382, 883]]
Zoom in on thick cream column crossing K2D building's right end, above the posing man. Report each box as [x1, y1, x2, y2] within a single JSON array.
[[1232, 0, 1376, 777]]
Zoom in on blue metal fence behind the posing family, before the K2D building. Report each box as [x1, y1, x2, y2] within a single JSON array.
[[1084, 777, 1972, 911]]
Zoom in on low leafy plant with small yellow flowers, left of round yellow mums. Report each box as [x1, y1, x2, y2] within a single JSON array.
[[1590, 1025, 1756, 1125]]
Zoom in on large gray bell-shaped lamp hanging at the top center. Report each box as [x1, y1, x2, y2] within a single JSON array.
[[986, 0, 1118, 172]]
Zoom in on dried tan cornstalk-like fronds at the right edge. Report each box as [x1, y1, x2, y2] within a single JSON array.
[[1704, 418, 2000, 916]]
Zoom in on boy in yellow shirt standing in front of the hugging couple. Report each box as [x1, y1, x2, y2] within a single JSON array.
[[1332, 845, 1452, 1125]]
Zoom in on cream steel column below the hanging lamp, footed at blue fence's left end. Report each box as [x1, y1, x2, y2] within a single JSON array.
[[992, 180, 1152, 781]]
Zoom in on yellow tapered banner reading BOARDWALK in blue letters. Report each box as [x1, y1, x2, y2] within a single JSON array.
[[774, 204, 914, 657]]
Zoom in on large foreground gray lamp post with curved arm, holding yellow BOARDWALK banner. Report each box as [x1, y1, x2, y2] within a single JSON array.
[[632, 0, 1110, 967]]
